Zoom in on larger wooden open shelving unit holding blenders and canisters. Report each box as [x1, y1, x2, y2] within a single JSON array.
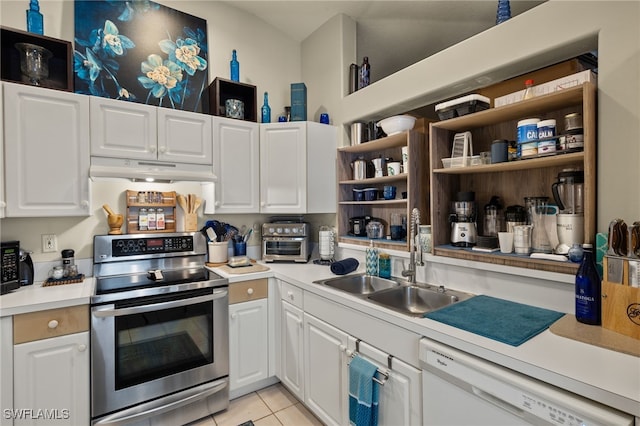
[[430, 82, 597, 274]]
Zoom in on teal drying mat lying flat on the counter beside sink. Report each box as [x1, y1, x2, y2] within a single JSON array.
[[424, 295, 564, 346]]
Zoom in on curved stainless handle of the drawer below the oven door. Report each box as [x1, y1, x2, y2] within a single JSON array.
[[92, 378, 229, 426]]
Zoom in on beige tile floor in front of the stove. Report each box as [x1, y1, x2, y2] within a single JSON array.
[[189, 383, 322, 426]]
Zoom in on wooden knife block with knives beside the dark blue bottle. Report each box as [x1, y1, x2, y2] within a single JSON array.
[[602, 256, 640, 340]]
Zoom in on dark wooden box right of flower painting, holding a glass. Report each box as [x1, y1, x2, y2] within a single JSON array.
[[208, 77, 258, 122]]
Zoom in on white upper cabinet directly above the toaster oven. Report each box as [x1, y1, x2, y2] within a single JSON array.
[[260, 122, 337, 213]]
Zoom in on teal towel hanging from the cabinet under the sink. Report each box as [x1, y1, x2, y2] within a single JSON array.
[[349, 355, 379, 426]]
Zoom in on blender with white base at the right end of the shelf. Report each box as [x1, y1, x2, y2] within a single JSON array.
[[551, 169, 584, 254]]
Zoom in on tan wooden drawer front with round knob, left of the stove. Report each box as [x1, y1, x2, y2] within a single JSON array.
[[13, 305, 89, 345]]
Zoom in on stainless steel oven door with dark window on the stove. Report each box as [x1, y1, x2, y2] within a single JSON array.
[[91, 287, 229, 418]]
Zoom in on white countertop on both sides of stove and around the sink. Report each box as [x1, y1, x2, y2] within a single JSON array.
[[0, 262, 640, 417]]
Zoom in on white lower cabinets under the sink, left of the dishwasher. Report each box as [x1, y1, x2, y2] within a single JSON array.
[[279, 281, 422, 426]]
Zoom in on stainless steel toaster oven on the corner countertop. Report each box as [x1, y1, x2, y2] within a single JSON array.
[[262, 222, 311, 263]]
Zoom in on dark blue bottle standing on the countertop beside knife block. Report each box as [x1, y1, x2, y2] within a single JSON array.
[[576, 244, 602, 325]]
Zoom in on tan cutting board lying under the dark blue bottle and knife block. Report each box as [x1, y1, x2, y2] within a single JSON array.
[[549, 314, 640, 357]]
